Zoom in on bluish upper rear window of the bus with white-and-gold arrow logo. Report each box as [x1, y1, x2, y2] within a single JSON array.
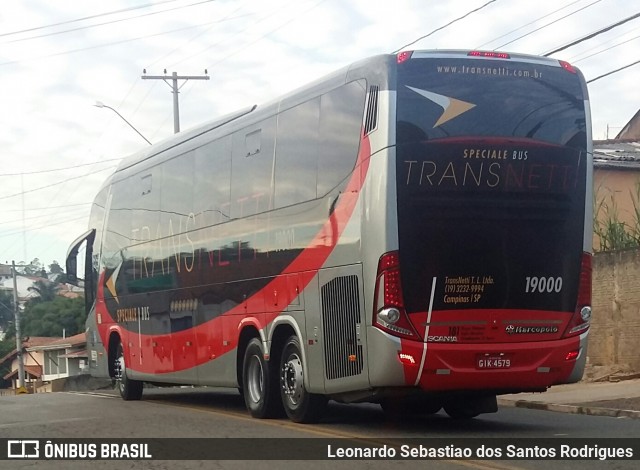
[[397, 58, 587, 149]]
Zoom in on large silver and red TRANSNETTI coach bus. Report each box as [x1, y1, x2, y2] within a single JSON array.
[[67, 50, 592, 422]]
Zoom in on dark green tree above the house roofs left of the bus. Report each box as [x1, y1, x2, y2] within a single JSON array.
[[20, 297, 86, 336]]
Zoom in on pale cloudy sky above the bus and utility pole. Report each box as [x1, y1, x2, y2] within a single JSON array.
[[0, 0, 640, 266]]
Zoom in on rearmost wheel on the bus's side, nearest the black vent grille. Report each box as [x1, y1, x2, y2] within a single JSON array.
[[280, 336, 327, 423]]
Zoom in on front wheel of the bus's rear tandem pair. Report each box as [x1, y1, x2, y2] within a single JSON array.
[[240, 338, 280, 419]]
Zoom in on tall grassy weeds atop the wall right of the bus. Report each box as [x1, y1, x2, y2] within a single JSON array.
[[593, 180, 640, 251]]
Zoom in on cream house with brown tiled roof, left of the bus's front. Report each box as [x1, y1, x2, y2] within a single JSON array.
[[0, 333, 89, 392]]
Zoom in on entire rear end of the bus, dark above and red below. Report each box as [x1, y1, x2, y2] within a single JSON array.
[[374, 51, 592, 415]]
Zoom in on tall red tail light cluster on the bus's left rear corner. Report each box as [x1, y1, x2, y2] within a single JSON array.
[[373, 251, 418, 339]]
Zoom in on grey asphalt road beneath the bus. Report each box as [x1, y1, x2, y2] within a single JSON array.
[[0, 388, 640, 470]]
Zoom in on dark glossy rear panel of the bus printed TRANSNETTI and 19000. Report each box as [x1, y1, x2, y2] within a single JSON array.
[[396, 57, 587, 342]]
